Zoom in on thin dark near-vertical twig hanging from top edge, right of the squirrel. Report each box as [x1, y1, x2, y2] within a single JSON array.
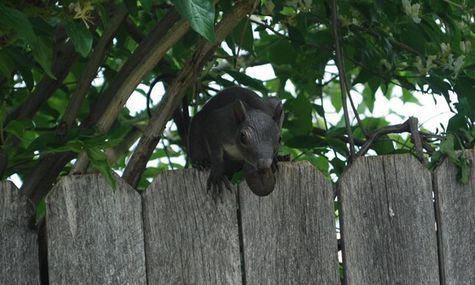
[[331, 0, 355, 160]]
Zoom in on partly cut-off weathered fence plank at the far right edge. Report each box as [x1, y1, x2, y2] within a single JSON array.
[[434, 150, 475, 284]]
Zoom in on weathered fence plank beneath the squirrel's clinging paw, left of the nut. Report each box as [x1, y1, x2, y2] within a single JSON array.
[[143, 169, 242, 284]]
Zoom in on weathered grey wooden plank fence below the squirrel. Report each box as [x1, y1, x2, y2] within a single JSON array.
[[0, 151, 475, 285]]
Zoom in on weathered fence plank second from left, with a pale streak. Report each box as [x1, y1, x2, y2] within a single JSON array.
[[46, 174, 146, 284]]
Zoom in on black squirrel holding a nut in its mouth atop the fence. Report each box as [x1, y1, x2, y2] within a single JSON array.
[[188, 87, 284, 199]]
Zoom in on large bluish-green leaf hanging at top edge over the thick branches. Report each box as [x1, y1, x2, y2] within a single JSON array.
[[171, 0, 215, 42]]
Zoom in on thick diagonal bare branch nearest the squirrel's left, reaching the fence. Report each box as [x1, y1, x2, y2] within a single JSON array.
[[123, 0, 258, 187]]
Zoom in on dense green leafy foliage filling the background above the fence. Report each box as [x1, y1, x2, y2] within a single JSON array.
[[0, 0, 475, 204]]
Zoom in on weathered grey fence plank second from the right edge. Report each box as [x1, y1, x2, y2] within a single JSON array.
[[339, 155, 439, 284]]
